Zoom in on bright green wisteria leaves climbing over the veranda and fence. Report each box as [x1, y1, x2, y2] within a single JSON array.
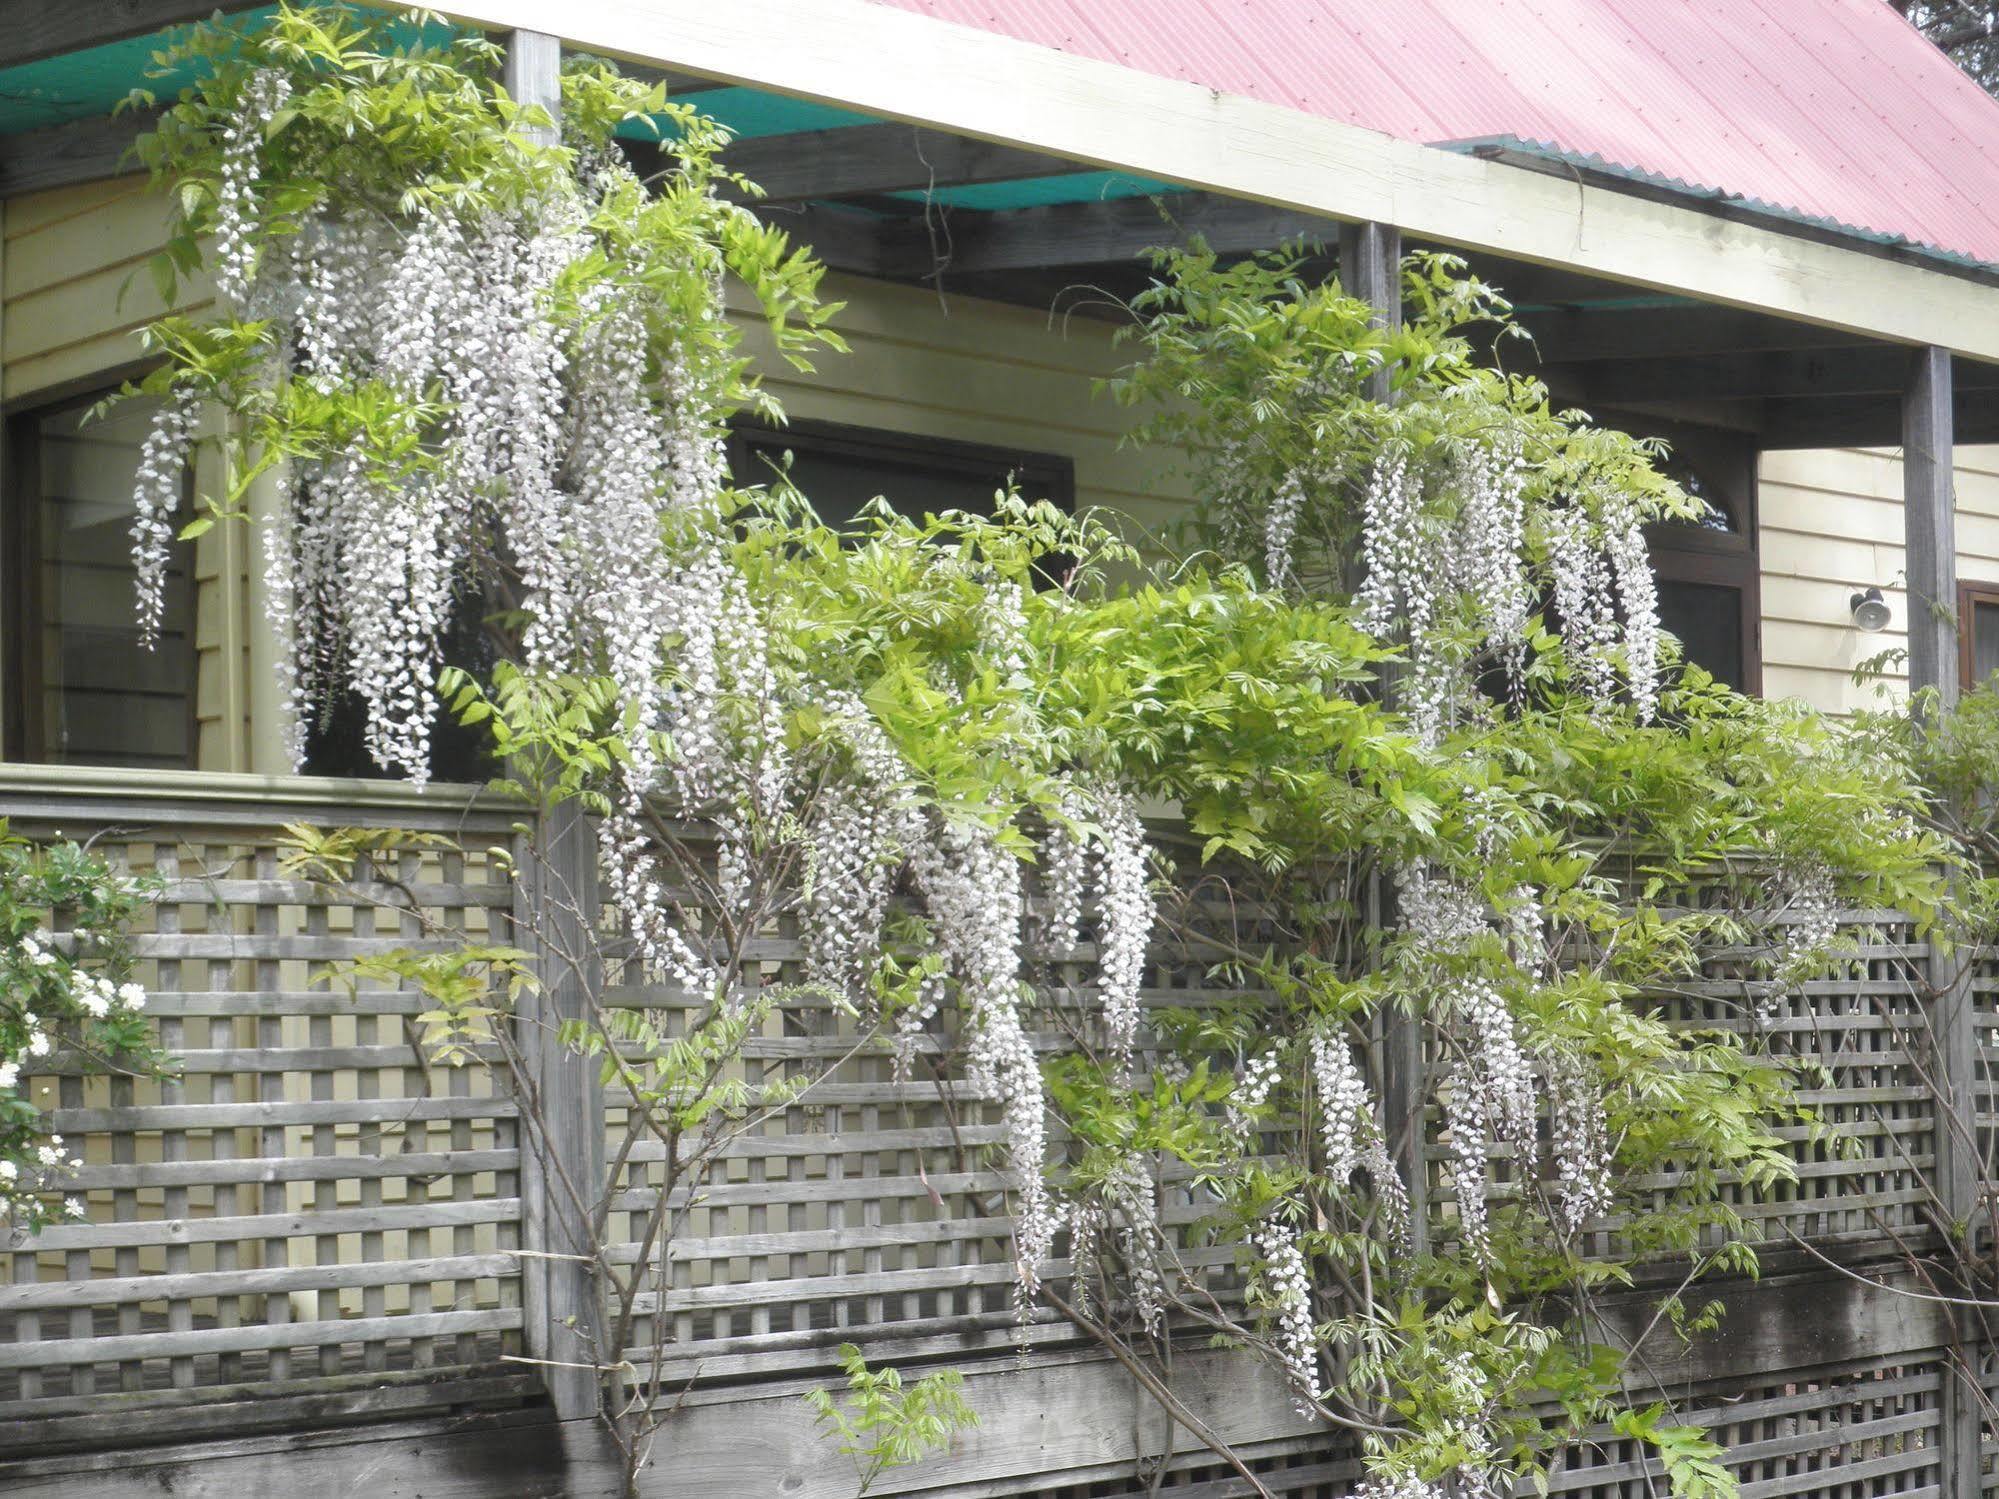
[[142, 8, 1967, 1499]]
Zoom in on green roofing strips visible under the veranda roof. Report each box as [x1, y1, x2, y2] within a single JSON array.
[[0, 10, 1179, 212]]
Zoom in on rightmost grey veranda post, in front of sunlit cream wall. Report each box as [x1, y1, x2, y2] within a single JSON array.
[[1901, 348, 1983, 1499]]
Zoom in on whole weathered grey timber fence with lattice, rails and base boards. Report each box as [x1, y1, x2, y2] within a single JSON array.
[[0, 769, 1999, 1499]]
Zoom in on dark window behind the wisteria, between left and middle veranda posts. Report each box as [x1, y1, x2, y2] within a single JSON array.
[[730, 422, 1075, 530]]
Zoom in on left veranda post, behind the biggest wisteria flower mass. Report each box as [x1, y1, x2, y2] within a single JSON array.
[[504, 32, 618, 1419]]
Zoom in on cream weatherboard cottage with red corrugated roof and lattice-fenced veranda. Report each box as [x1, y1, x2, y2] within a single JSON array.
[[0, 0, 1999, 1499]]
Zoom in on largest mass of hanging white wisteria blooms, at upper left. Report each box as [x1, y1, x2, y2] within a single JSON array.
[[122, 40, 812, 801]]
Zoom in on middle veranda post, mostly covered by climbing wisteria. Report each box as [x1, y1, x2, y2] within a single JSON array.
[[1339, 224, 1429, 1253]]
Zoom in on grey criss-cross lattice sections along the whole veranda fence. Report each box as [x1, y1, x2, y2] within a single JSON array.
[[0, 793, 1975, 1499]]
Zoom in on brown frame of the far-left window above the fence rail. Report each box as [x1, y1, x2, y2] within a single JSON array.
[[0, 375, 202, 769]]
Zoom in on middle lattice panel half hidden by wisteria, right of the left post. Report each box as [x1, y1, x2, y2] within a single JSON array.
[[606, 855, 1269, 1379]]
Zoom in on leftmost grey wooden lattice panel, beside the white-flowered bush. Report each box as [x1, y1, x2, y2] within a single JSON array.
[[0, 801, 522, 1417]]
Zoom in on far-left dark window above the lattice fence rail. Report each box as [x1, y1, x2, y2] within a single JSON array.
[[0, 392, 196, 769]]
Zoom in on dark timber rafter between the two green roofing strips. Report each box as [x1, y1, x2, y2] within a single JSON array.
[[722, 124, 1087, 204]]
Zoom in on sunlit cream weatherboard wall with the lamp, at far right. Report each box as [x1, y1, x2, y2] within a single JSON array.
[[1757, 448, 1999, 712]]
